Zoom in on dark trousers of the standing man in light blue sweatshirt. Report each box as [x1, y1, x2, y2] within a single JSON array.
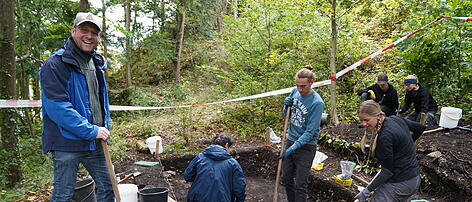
[[282, 140, 316, 202]]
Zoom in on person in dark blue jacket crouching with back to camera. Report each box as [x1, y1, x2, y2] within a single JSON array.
[[184, 133, 246, 202]]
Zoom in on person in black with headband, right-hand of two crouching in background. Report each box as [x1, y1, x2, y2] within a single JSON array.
[[400, 75, 438, 125]]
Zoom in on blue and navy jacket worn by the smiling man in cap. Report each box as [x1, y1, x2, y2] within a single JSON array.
[[38, 38, 110, 153]]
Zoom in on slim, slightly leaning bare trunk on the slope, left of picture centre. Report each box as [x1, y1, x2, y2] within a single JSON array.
[[174, 0, 186, 84]]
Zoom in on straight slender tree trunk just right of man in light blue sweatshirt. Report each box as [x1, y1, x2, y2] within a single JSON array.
[[329, 0, 339, 125]]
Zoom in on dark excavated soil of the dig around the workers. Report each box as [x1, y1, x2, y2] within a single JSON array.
[[114, 123, 472, 201]]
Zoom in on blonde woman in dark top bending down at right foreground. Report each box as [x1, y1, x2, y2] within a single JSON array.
[[355, 100, 426, 202]]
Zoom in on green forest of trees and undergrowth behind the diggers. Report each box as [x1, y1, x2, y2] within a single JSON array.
[[0, 0, 472, 201]]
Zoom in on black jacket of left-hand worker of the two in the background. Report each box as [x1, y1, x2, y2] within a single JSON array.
[[357, 83, 398, 116]]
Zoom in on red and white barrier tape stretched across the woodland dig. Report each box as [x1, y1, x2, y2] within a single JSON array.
[[0, 16, 472, 111]]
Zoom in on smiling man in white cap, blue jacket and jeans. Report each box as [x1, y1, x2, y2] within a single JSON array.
[[39, 13, 114, 202]]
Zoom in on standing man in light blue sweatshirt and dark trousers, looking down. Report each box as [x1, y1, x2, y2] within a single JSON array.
[[282, 68, 324, 202]]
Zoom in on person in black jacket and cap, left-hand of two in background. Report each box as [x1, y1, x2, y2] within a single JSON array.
[[357, 73, 399, 116]]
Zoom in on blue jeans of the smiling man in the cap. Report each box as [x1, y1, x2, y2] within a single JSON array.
[[51, 141, 115, 202]]
